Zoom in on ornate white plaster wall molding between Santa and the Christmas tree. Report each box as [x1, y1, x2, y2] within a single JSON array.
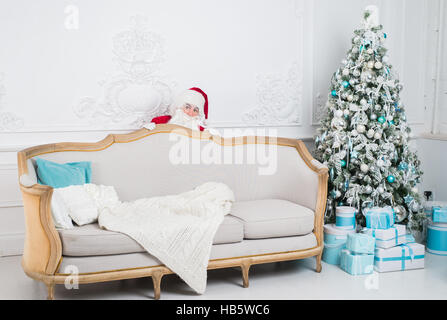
[[242, 62, 303, 126]]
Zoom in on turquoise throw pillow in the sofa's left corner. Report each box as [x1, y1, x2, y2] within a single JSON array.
[[36, 158, 92, 188]]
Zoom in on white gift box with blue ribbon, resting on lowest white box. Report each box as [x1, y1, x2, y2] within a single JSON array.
[[361, 224, 414, 249]]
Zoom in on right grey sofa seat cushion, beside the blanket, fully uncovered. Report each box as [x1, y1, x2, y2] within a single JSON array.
[[231, 199, 314, 239]]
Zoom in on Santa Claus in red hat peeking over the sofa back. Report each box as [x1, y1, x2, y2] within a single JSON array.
[[144, 88, 208, 131]]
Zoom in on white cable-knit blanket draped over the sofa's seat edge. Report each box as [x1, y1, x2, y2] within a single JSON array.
[[98, 182, 234, 293]]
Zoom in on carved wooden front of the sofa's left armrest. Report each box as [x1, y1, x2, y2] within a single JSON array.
[[18, 152, 62, 274]]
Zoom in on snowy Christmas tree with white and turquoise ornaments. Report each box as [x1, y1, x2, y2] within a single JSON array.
[[315, 7, 425, 231]]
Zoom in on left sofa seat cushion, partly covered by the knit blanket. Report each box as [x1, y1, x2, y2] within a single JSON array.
[[58, 215, 244, 256]]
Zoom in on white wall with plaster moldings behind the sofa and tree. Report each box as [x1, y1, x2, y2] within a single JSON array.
[[0, 0, 447, 254]]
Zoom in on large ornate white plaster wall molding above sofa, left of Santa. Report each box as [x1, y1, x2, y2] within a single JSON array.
[[73, 15, 175, 128]]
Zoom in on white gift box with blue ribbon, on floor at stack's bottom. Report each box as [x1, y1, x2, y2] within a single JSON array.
[[374, 243, 425, 272]]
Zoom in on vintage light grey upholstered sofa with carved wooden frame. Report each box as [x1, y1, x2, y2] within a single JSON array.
[[18, 124, 328, 299]]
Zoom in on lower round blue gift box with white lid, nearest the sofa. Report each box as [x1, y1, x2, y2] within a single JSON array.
[[323, 224, 355, 265]]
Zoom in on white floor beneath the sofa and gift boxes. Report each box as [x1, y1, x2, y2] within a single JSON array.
[[0, 253, 447, 300]]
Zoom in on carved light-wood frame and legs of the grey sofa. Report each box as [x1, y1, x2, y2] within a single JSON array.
[[18, 124, 328, 299]]
